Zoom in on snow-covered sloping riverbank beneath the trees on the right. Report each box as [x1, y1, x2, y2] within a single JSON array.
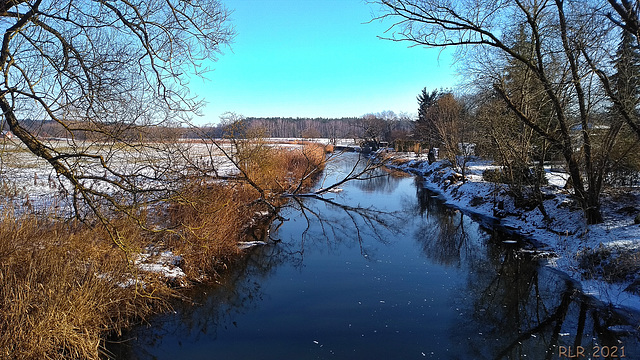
[[385, 153, 640, 324]]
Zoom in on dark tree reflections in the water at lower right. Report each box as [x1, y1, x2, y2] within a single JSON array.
[[462, 234, 637, 359]]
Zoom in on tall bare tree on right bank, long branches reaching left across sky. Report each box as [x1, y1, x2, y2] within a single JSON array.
[[376, 0, 615, 224]]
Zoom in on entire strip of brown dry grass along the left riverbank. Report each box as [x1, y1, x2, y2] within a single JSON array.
[[0, 144, 325, 359]]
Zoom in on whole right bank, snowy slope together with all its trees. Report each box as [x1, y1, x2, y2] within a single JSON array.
[[364, 0, 640, 324]]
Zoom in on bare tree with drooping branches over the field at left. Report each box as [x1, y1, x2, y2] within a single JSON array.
[[0, 0, 233, 239]]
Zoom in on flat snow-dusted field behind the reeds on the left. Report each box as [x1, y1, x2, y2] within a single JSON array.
[[0, 141, 245, 214]]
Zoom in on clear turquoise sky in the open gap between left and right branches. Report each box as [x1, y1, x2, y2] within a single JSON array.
[[190, 0, 456, 124]]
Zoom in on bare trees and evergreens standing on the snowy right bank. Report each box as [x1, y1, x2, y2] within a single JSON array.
[[375, 0, 640, 224]]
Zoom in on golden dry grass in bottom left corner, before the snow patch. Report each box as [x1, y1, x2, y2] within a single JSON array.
[[0, 212, 169, 359]]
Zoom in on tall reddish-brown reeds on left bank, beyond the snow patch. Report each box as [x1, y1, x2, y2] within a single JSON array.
[[167, 145, 325, 278]]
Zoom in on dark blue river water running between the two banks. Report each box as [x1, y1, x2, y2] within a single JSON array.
[[109, 157, 640, 359]]
